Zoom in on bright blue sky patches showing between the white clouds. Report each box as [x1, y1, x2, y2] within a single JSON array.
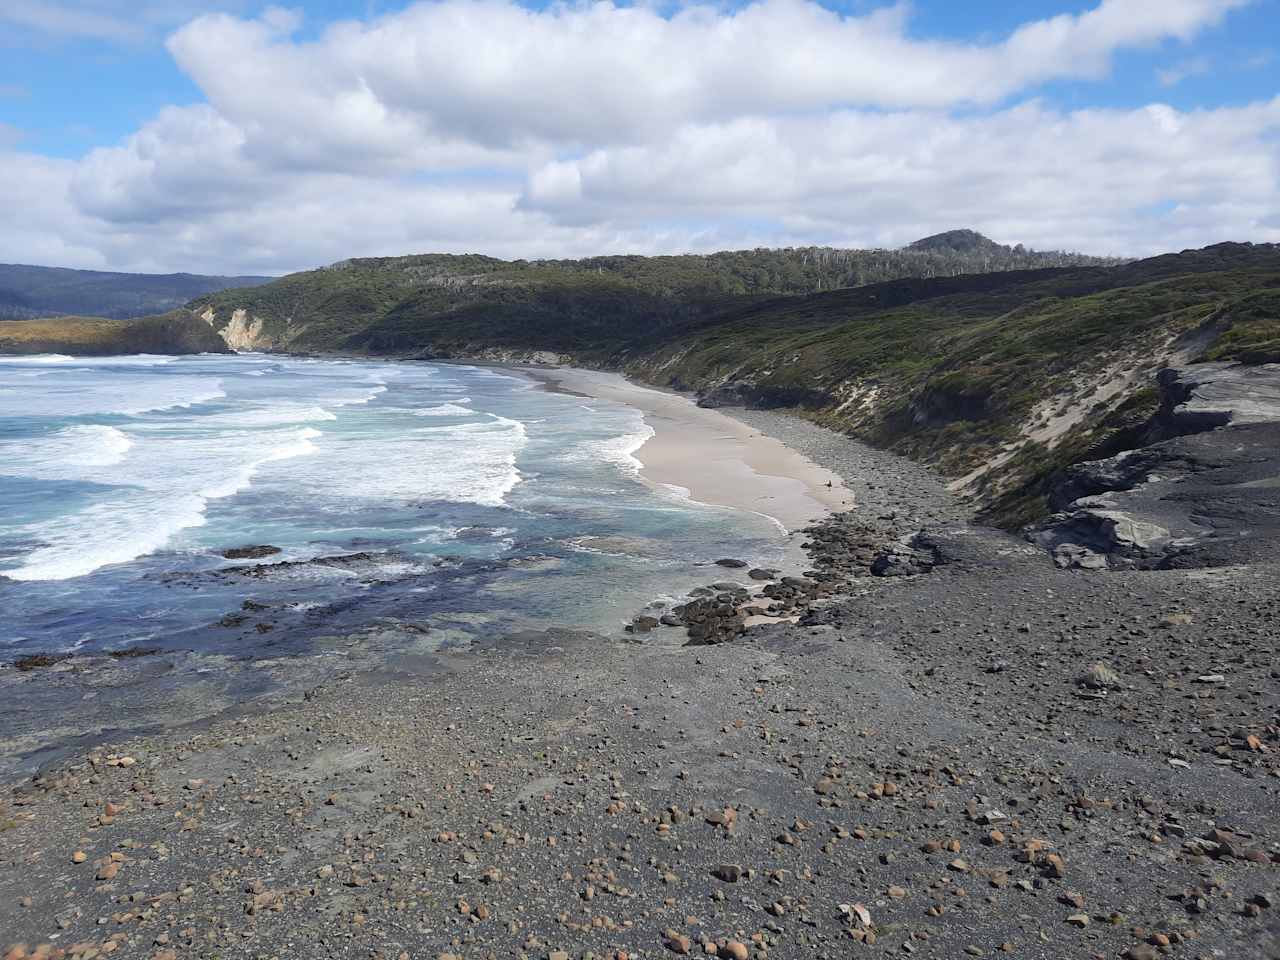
[[0, 0, 1280, 157]]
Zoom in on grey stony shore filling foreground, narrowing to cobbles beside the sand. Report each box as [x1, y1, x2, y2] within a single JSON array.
[[0, 391, 1280, 960]]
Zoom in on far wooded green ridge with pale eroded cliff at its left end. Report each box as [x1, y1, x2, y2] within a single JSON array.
[[191, 234, 1117, 353]]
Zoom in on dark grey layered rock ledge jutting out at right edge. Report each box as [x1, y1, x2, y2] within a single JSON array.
[[1028, 364, 1280, 570]]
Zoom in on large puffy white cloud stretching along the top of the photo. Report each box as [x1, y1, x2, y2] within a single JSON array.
[[169, 0, 1249, 151]]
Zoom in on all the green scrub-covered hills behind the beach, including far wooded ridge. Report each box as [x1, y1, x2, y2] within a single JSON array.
[[191, 238, 1280, 527]]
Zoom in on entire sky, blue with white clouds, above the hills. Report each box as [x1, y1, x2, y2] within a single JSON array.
[[0, 0, 1280, 275]]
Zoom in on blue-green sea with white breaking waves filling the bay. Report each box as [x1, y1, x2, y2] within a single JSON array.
[[0, 355, 786, 658]]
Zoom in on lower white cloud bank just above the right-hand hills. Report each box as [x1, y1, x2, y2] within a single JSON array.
[[522, 99, 1280, 253]]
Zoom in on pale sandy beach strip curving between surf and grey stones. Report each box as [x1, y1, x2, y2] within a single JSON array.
[[522, 367, 854, 532]]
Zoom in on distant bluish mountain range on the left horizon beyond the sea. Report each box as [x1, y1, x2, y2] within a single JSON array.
[[0, 264, 271, 320]]
